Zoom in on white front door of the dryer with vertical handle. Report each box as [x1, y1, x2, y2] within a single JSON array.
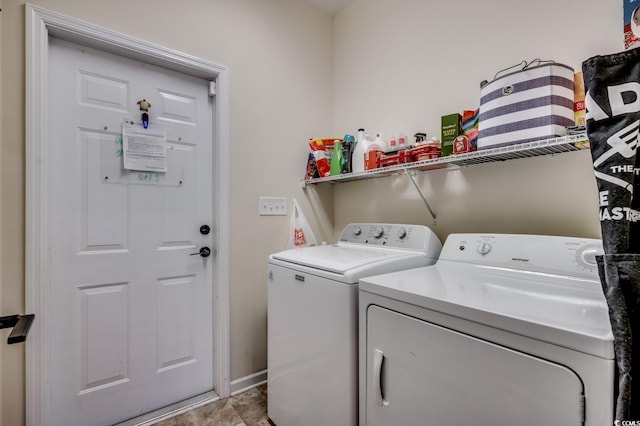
[[364, 305, 583, 426]]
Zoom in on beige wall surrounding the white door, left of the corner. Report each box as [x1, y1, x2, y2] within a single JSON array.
[[0, 0, 333, 426]]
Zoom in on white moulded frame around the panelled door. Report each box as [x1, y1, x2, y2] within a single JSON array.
[[25, 4, 230, 426]]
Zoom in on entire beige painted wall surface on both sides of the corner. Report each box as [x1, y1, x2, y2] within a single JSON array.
[[0, 0, 622, 426]]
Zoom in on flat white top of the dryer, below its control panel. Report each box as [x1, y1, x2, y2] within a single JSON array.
[[360, 260, 614, 359]]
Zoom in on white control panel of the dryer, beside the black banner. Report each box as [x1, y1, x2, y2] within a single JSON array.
[[439, 234, 604, 279]]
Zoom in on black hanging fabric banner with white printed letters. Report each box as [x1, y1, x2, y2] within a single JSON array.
[[582, 49, 640, 421]]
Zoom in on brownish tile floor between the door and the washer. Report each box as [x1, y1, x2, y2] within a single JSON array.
[[155, 384, 270, 426]]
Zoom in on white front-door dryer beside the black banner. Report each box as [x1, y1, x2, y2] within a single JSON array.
[[359, 234, 614, 426]]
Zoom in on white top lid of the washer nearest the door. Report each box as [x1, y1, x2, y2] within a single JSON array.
[[270, 244, 425, 275]]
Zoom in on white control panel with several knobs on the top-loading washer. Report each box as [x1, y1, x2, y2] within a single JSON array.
[[338, 223, 441, 251]]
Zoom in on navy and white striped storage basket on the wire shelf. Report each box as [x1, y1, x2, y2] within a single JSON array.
[[478, 63, 574, 150]]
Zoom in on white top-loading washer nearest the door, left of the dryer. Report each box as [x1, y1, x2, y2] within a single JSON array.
[[268, 223, 441, 426]]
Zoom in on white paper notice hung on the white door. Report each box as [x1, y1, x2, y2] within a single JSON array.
[[122, 121, 167, 172]]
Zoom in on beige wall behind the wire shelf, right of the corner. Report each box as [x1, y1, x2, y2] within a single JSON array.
[[334, 0, 623, 240]]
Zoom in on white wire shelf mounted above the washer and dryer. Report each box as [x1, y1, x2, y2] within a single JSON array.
[[301, 132, 589, 186]]
